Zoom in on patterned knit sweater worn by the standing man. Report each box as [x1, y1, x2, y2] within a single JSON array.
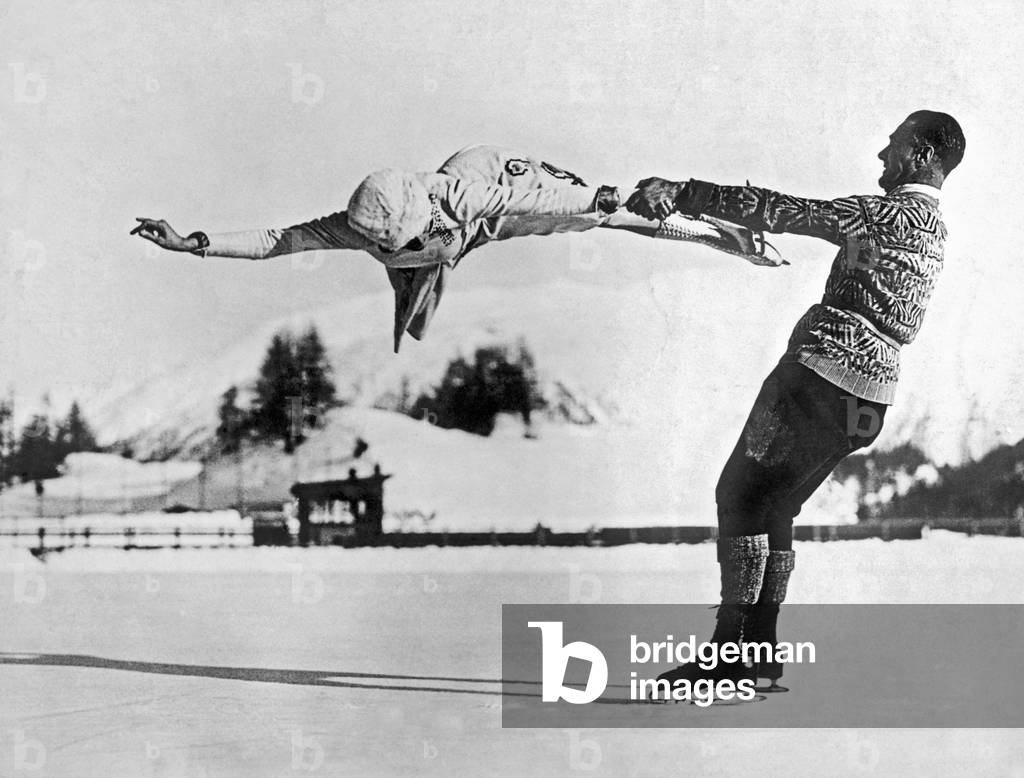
[[676, 180, 946, 404]]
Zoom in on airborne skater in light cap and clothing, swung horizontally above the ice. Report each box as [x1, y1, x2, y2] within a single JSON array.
[[132, 145, 782, 351]]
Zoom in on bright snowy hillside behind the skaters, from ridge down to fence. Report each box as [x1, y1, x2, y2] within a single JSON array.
[[59, 240, 1024, 529]]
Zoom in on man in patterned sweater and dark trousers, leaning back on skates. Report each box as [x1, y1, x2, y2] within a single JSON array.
[[627, 111, 965, 690]]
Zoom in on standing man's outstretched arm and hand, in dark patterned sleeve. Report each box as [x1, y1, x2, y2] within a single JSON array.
[[626, 178, 864, 245]]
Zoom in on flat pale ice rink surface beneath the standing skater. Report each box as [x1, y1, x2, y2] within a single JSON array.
[[0, 532, 1024, 776]]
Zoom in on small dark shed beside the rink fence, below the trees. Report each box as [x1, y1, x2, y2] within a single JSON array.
[[291, 465, 391, 546]]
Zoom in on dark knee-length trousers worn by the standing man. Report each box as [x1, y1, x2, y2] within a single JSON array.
[[715, 362, 886, 551]]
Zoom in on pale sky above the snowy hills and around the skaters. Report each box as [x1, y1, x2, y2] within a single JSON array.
[[0, 0, 1011, 419]]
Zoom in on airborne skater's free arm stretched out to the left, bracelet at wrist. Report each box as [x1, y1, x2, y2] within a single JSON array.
[[131, 211, 370, 259]]
